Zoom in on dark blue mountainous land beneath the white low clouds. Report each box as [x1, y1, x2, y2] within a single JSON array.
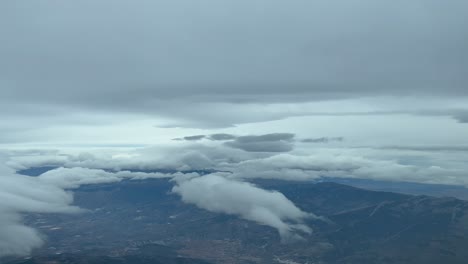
[[6, 179, 468, 264]]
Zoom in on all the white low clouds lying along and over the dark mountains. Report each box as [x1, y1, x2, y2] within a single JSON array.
[[0, 133, 468, 256]]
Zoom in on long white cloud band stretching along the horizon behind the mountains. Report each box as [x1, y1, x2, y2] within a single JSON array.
[[8, 140, 468, 186]]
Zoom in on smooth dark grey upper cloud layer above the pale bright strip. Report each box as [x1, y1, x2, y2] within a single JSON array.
[[0, 0, 468, 127]]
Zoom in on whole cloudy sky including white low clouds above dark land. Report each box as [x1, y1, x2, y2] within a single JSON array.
[[0, 0, 468, 256]]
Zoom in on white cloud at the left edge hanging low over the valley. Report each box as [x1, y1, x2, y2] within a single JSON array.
[[0, 156, 81, 257]]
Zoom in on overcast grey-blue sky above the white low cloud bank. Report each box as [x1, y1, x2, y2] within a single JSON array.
[[0, 0, 468, 146]]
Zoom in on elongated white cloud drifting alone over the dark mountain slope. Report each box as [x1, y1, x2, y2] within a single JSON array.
[[173, 174, 316, 241]]
